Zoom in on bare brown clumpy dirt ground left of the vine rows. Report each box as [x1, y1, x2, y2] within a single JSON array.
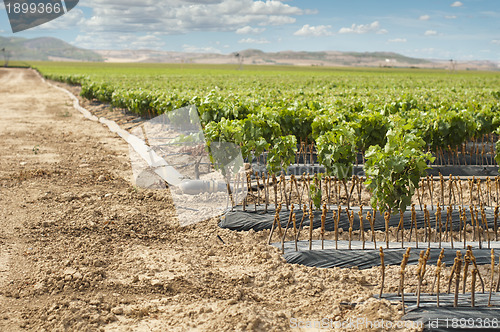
[[0, 69, 418, 331]]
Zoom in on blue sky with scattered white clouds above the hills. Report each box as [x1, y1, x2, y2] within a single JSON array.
[[0, 0, 500, 62]]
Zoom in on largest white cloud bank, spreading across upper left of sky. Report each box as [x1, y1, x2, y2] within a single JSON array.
[[71, 0, 306, 49]]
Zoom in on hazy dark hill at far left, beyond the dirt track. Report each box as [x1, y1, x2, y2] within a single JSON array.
[[0, 37, 103, 61]]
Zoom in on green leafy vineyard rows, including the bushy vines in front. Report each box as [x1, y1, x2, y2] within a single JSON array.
[[27, 63, 500, 211]]
